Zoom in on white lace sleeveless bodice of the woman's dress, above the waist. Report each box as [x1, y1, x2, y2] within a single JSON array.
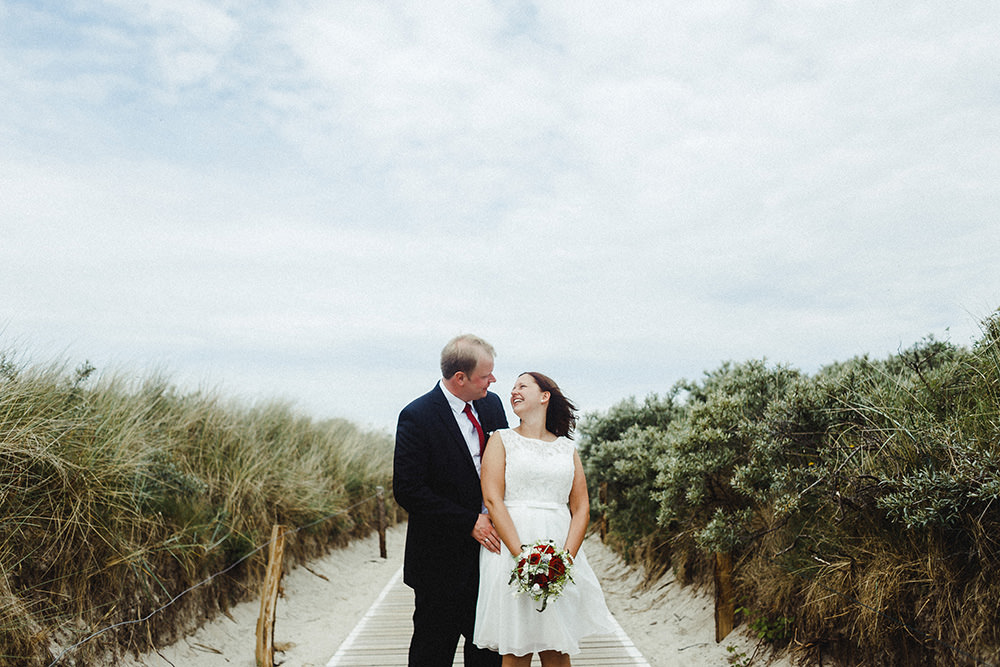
[[500, 429, 575, 504]]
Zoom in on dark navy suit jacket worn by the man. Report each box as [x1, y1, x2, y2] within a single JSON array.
[[392, 385, 507, 589]]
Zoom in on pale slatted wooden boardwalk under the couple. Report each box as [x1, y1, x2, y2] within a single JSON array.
[[327, 569, 649, 667]]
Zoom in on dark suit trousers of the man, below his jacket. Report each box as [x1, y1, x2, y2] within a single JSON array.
[[409, 583, 501, 667]]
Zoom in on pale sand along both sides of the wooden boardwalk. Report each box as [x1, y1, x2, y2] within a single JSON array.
[[123, 525, 792, 667]]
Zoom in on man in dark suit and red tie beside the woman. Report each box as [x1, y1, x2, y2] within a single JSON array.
[[392, 335, 507, 667]]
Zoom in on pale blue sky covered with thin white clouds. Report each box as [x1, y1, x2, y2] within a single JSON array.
[[0, 0, 1000, 430]]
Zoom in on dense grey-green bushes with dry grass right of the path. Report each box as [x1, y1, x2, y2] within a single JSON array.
[[581, 312, 1000, 667]]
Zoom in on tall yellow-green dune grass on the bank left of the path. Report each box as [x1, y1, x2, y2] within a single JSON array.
[[0, 352, 392, 666]]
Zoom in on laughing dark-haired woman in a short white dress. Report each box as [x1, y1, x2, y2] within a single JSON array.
[[473, 372, 613, 667]]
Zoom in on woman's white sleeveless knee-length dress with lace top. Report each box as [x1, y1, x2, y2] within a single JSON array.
[[473, 429, 613, 655]]
